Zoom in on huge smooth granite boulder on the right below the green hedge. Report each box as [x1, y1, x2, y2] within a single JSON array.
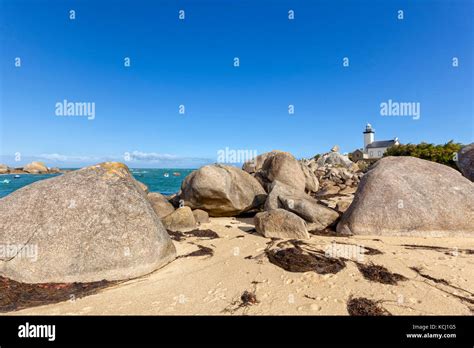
[[337, 157, 474, 237]]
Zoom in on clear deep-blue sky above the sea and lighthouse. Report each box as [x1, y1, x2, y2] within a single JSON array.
[[0, 0, 474, 167]]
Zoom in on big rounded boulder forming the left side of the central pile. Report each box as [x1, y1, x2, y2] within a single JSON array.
[[180, 164, 267, 216]]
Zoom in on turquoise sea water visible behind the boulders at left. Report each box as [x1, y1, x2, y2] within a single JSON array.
[[0, 168, 195, 198]]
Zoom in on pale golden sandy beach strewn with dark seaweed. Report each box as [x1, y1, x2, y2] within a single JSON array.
[[6, 218, 474, 315]]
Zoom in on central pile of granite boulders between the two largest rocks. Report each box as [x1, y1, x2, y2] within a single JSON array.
[[172, 151, 339, 238]]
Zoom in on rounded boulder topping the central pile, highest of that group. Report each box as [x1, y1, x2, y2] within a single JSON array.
[[255, 151, 306, 192]]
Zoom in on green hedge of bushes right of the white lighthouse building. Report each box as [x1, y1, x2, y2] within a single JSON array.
[[384, 140, 463, 170]]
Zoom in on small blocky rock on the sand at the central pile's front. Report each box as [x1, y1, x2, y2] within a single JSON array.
[[254, 209, 309, 239]]
